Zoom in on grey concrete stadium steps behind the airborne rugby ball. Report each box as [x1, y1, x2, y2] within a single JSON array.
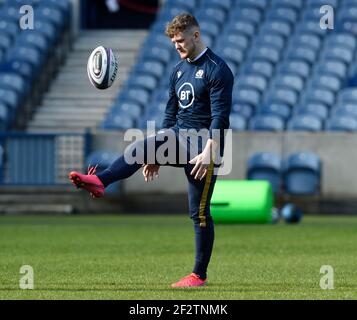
[[27, 30, 147, 133]]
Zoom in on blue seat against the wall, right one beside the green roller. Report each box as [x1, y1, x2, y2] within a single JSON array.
[[283, 152, 321, 195]]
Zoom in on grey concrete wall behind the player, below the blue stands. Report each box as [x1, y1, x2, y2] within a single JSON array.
[[93, 132, 357, 199]]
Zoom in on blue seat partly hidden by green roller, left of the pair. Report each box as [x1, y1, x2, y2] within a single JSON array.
[[246, 152, 281, 193]]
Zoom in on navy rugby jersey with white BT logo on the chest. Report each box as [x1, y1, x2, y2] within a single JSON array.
[[162, 48, 234, 137]]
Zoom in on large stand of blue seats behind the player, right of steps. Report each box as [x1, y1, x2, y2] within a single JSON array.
[[101, 0, 357, 131]]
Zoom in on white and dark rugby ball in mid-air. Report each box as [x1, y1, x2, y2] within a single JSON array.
[[87, 46, 119, 90]]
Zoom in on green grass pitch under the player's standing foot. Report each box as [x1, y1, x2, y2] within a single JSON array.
[[0, 215, 357, 300]]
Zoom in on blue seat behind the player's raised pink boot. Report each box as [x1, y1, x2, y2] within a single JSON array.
[[86, 150, 121, 195]]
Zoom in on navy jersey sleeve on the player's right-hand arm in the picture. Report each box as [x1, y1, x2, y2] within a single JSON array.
[[209, 65, 234, 138]]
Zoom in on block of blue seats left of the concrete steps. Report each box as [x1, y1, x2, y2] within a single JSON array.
[[0, 0, 71, 130]]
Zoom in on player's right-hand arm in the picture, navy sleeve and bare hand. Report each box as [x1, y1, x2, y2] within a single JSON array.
[[190, 66, 234, 180]]
